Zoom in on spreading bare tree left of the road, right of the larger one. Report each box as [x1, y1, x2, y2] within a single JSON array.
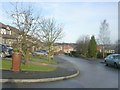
[[36, 18, 63, 61]]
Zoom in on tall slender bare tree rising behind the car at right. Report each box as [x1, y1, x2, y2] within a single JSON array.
[[99, 20, 110, 58]]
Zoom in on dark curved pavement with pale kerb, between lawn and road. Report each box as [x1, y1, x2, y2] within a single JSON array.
[[0, 57, 79, 83]]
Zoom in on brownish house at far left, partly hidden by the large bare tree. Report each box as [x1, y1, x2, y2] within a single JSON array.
[[0, 22, 41, 51]]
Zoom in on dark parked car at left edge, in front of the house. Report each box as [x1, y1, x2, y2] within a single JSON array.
[[0, 44, 13, 58]]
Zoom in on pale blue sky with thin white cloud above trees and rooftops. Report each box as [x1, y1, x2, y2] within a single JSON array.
[[0, 1, 118, 43]]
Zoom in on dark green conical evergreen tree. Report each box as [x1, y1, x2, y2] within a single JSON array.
[[88, 36, 97, 58]]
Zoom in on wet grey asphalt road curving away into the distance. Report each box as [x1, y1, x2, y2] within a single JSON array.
[[3, 55, 119, 88]]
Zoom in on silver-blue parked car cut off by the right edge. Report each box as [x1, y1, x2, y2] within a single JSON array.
[[105, 54, 120, 68]]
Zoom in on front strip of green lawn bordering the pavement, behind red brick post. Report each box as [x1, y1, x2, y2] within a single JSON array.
[[0, 60, 56, 71]]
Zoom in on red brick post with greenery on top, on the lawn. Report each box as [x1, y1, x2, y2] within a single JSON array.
[[12, 52, 22, 72]]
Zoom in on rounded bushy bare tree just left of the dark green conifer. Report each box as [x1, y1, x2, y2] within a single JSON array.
[[76, 35, 90, 57]]
